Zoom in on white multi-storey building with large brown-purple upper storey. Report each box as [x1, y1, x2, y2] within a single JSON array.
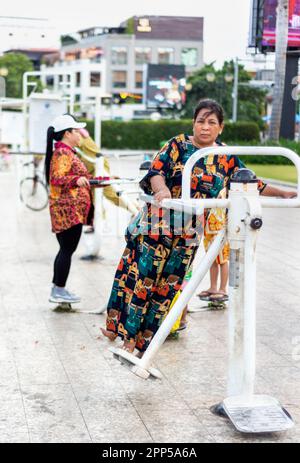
[[43, 16, 203, 110]]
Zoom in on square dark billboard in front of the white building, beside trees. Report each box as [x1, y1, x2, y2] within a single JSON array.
[[144, 64, 186, 109]]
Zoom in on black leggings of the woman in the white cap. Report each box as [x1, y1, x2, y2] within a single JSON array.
[[53, 223, 82, 288]]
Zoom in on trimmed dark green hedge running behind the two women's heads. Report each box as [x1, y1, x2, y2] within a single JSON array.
[[80, 120, 259, 150]]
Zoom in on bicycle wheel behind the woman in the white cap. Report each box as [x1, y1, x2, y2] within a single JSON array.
[[20, 177, 48, 211]]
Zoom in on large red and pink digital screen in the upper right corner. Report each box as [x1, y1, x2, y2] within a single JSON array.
[[261, 0, 300, 49]]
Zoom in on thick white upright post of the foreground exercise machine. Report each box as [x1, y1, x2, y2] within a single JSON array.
[[227, 183, 261, 397]]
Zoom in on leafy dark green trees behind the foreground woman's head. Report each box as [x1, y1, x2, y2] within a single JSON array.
[[184, 61, 266, 127]]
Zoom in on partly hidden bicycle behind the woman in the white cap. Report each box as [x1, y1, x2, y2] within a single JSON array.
[[20, 158, 48, 211]]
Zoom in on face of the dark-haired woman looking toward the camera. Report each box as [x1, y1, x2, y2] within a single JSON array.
[[193, 108, 224, 146]]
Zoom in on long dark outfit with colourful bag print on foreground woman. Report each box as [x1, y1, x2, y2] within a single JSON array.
[[106, 134, 264, 352]]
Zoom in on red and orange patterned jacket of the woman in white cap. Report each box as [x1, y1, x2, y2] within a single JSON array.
[[49, 142, 92, 233]]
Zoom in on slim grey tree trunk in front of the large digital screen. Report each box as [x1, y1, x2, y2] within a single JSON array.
[[269, 0, 289, 141]]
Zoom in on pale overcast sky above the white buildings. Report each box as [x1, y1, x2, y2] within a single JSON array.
[[0, 0, 251, 65]]
